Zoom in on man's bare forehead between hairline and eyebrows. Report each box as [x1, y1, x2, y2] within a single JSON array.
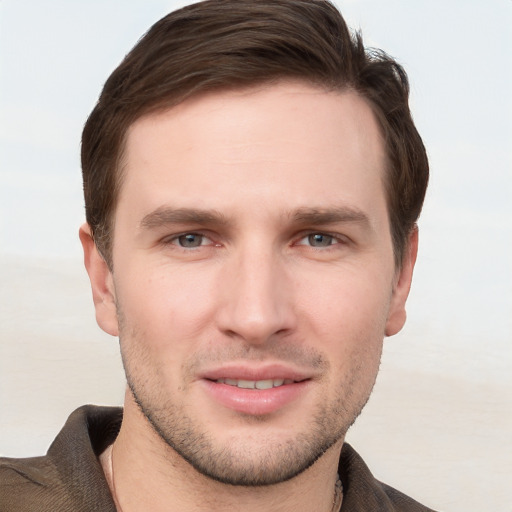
[[118, 82, 385, 220]]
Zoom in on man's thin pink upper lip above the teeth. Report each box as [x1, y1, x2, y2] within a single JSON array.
[[199, 364, 313, 382]]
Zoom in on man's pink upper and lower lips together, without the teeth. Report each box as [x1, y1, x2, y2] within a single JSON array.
[[199, 365, 312, 416]]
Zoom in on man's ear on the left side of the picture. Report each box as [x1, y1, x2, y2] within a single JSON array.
[[79, 224, 119, 336]]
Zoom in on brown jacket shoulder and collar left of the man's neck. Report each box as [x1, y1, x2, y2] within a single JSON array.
[[0, 406, 122, 512]]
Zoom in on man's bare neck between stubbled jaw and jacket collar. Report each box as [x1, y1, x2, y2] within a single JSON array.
[[102, 401, 342, 512]]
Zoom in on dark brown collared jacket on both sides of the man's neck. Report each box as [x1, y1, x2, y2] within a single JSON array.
[[0, 405, 433, 512]]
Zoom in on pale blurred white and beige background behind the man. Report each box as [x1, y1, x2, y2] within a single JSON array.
[[0, 0, 512, 512]]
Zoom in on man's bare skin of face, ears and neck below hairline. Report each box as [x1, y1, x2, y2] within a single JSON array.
[[80, 82, 417, 512]]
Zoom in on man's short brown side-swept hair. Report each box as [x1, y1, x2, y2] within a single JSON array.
[[82, 0, 428, 266]]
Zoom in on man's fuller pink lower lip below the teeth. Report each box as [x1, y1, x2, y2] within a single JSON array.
[[202, 379, 310, 416]]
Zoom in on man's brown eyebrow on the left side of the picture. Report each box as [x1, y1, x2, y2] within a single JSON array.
[[140, 206, 228, 229]]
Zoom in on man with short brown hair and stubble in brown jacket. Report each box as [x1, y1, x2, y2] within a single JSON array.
[[0, 0, 430, 512]]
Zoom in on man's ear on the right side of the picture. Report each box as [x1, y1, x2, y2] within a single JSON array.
[[385, 226, 418, 336]]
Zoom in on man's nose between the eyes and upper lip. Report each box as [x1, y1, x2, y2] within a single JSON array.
[[217, 245, 297, 345]]
